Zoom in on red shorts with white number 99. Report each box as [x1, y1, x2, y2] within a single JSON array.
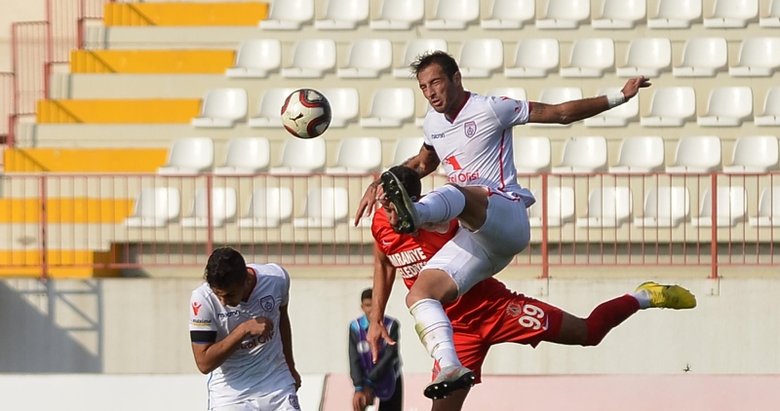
[[433, 292, 563, 383]]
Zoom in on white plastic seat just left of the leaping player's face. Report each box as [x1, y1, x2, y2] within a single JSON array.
[[360, 87, 414, 128]]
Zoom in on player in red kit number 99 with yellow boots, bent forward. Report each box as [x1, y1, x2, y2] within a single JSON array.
[[367, 166, 696, 411]]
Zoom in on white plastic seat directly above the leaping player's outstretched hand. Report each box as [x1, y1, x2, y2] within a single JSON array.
[[616, 37, 672, 77]]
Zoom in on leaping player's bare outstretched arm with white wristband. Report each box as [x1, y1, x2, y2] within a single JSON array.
[[528, 76, 651, 124]]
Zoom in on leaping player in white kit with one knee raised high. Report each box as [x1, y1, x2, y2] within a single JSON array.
[[355, 51, 695, 399]]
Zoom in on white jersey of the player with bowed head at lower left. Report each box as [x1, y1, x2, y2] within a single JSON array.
[[190, 264, 295, 408]]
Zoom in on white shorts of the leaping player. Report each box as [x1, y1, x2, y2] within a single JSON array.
[[423, 190, 531, 296]]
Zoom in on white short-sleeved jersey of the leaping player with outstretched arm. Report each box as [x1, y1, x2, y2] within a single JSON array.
[[423, 93, 534, 206]]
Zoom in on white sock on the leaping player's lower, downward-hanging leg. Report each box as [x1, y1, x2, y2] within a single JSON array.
[[409, 298, 461, 368]]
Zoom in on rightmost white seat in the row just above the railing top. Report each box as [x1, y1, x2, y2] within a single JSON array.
[[723, 136, 780, 173]]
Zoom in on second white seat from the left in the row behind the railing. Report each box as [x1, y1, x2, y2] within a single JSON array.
[[181, 187, 237, 228]]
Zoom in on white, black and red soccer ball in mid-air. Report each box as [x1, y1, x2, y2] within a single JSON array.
[[282, 88, 331, 138]]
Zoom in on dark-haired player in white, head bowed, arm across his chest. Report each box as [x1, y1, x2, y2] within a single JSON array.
[[190, 247, 301, 411]]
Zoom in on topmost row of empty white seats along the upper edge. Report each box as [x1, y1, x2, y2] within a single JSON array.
[[260, 0, 780, 30]]
